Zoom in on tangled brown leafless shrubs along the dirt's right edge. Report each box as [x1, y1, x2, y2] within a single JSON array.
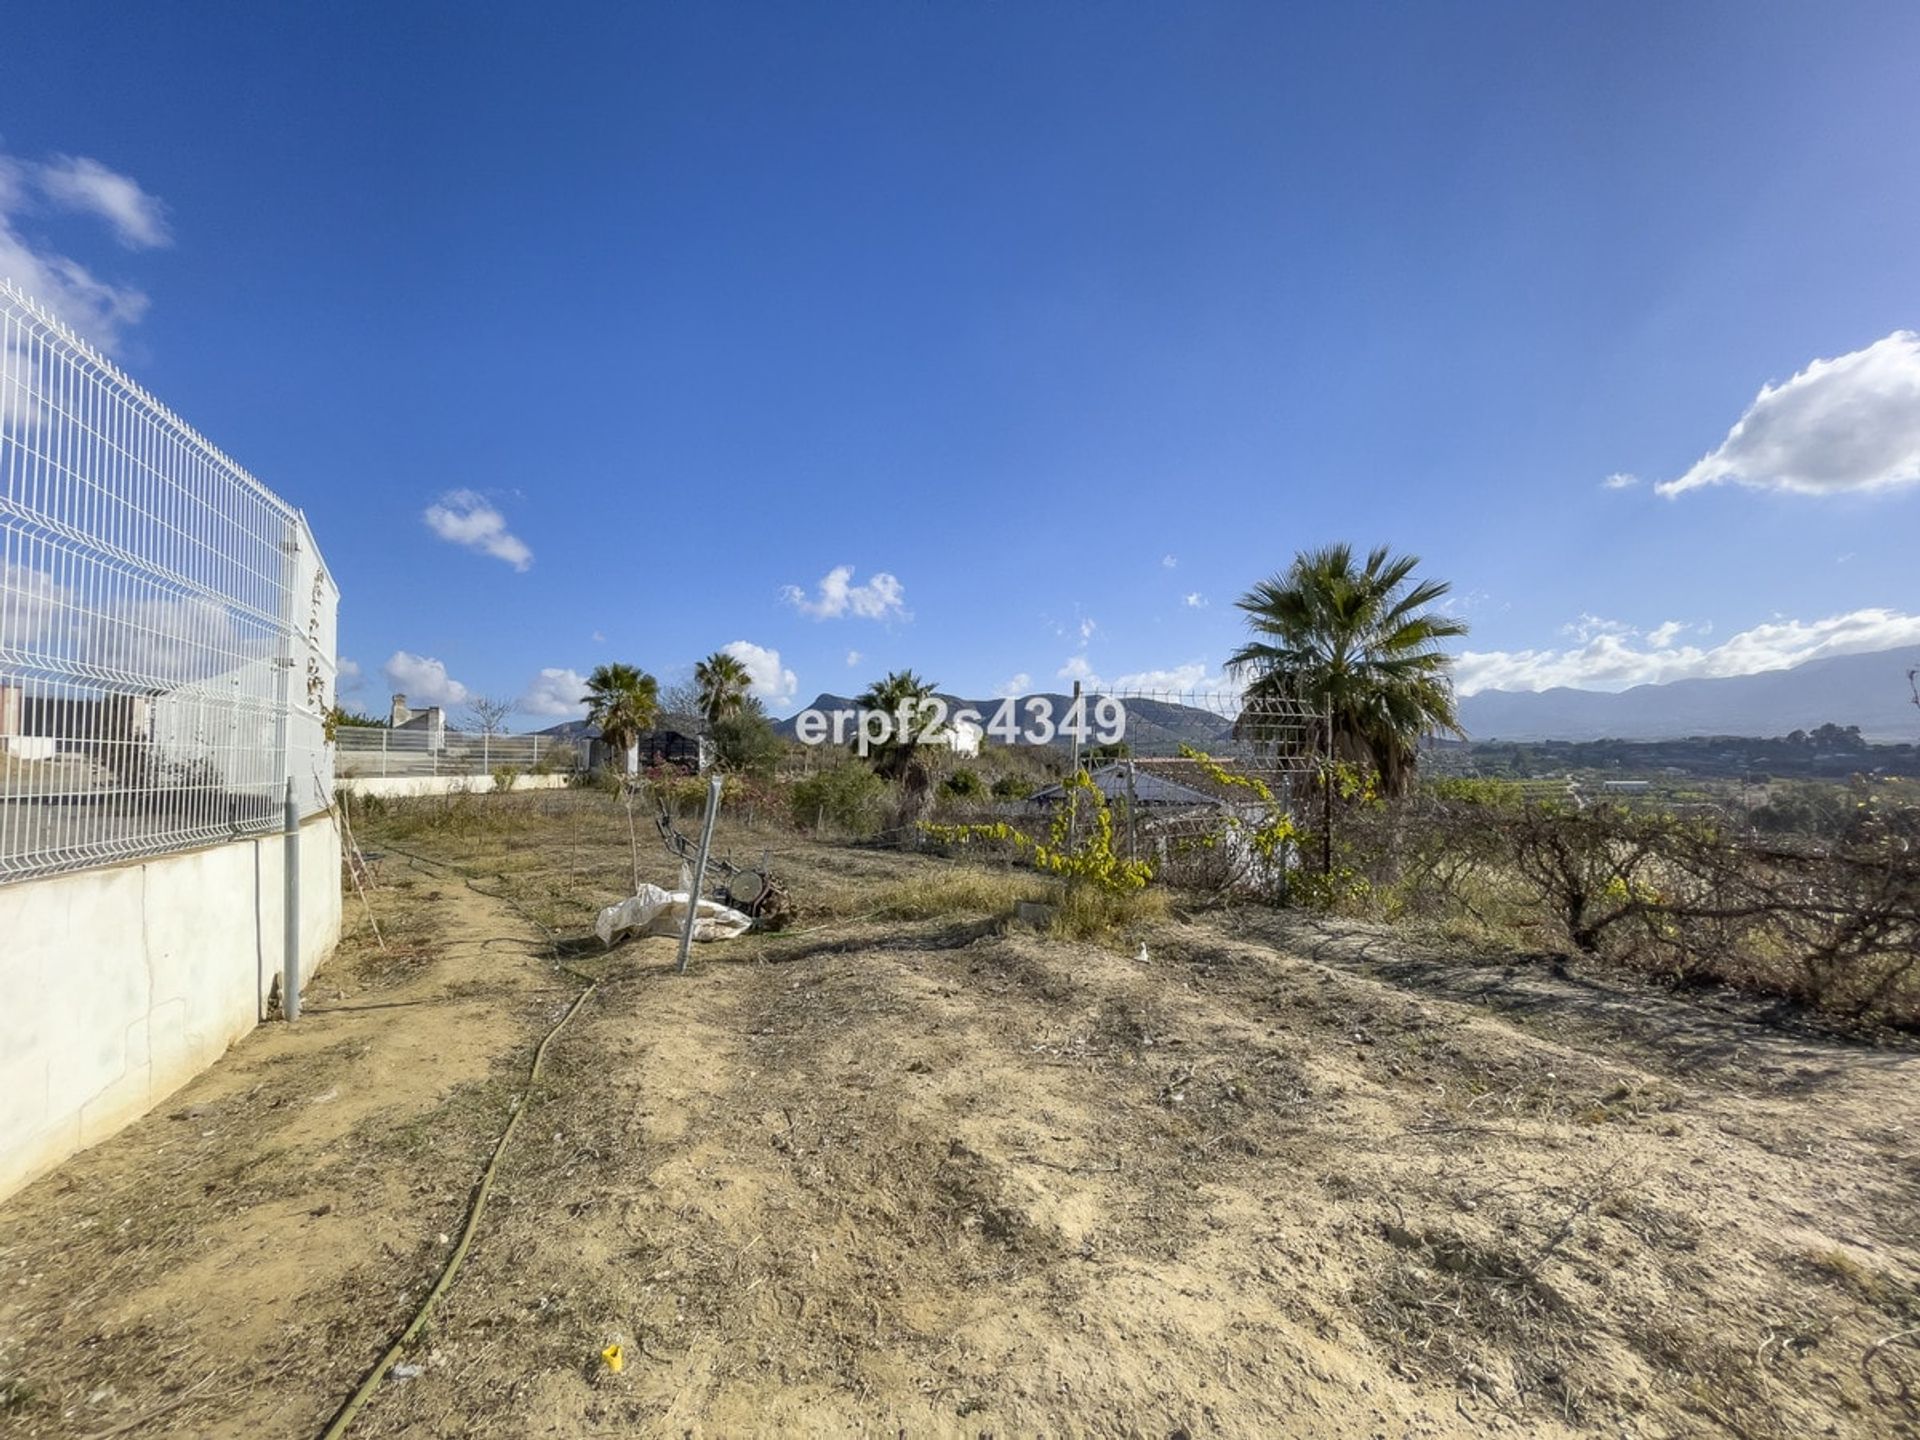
[[1336, 799, 1920, 1027]]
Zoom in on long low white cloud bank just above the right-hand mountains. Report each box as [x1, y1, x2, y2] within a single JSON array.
[[1453, 609, 1920, 695]]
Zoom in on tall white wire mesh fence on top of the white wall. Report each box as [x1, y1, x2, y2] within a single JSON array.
[[0, 270, 338, 881]]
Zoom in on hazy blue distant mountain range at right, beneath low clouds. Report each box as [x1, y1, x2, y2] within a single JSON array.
[[1459, 647, 1920, 741]]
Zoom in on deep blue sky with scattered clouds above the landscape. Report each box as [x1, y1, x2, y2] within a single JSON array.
[[0, 4, 1920, 726]]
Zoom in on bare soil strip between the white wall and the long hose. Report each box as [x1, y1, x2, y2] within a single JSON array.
[[0, 860, 574, 1436]]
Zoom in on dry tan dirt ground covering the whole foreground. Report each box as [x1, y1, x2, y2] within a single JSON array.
[[0, 793, 1920, 1440]]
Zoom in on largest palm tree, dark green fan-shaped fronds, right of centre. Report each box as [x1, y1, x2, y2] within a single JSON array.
[[1227, 543, 1467, 795]]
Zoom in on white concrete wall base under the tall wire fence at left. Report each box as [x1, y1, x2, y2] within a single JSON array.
[[0, 812, 340, 1198]]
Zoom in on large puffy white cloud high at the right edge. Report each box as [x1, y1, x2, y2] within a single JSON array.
[[1655, 330, 1920, 495]]
